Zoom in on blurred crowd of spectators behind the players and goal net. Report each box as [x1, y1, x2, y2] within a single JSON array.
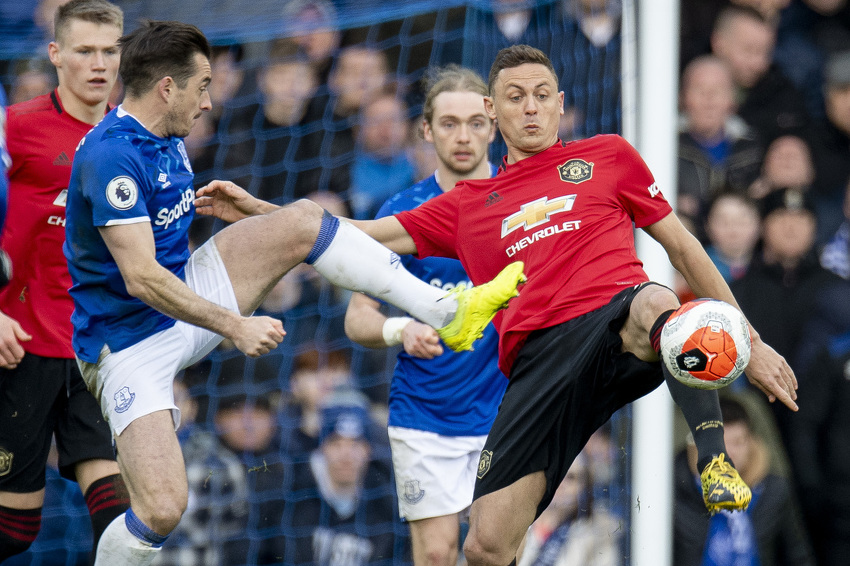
[[4, 0, 850, 566]]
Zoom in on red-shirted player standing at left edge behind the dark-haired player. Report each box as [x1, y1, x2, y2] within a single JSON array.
[[0, 0, 128, 562]]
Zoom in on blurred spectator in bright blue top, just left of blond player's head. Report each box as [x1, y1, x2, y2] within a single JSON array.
[[349, 92, 416, 219]]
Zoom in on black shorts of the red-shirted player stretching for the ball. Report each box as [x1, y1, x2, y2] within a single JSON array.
[[473, 286, 664, 516]]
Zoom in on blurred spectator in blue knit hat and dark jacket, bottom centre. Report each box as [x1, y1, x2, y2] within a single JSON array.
[[238, 389, 403, 566]]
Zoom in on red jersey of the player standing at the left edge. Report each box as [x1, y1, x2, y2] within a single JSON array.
[[0, 90, 103, 358]]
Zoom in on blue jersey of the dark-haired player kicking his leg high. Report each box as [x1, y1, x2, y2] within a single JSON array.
[[64, 106, 195, 363]]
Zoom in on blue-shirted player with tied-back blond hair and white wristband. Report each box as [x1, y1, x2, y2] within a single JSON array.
[[345, 66, 508, 566]]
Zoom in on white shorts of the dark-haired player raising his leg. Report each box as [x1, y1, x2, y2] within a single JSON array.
[[77, 238, 239, 436]]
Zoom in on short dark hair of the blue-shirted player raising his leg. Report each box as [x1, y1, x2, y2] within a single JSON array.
[[118, 20, 212, 96]]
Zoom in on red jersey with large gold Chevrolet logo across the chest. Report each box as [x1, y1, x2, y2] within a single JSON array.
[[397, 135, 672, 375]]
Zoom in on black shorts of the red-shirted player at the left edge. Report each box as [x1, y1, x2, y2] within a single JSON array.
[[0, 354, 115, 493]]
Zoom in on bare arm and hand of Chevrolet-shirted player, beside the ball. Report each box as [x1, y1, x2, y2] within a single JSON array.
[[645, 213, 797, 411]]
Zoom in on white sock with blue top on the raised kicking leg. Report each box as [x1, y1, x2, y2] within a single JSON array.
[[307, 214, 457, 328]]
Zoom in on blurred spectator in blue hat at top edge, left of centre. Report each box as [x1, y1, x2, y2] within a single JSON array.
[[283, 0, 342, 84]]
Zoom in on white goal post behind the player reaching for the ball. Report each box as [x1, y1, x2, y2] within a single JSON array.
[[622, 0, 679, 566]]
